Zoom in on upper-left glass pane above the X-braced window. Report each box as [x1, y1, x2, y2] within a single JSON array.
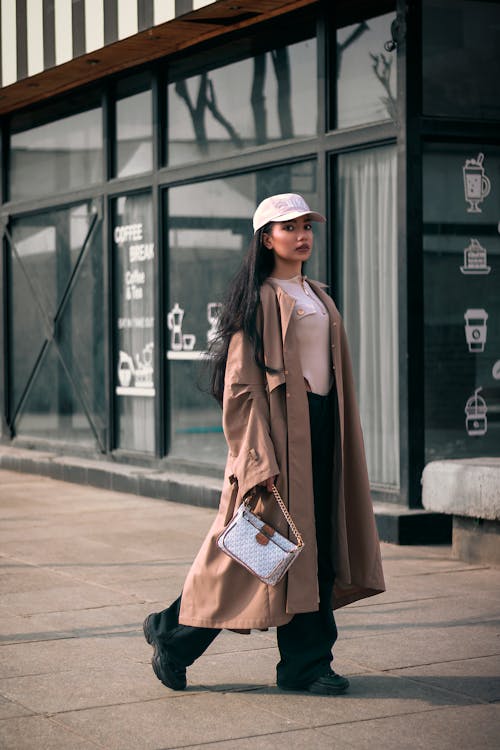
[[10, 108, 103, 200]]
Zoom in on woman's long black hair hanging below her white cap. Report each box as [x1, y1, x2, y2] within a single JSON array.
[[209, 222, 274, 404]]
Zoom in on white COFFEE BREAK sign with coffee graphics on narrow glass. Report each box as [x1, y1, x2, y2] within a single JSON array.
[[113, 195, 155, 397]]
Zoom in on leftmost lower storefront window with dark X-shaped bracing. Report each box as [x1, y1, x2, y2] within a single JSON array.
[[9, 202, 106, 450]]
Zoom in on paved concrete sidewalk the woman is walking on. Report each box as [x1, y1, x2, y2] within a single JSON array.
[[0, 471, 500, 750]]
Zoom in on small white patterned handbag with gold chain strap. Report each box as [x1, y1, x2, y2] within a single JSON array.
[[217, 484, 304, 586]]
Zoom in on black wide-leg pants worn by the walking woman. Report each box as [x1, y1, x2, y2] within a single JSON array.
[[146, 391, 337, 687]]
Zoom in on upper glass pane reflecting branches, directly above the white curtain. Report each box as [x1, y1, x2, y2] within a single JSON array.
[[337, 13, 397, 128]]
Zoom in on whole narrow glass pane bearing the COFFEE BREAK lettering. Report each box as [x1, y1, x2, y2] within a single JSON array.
[[113, 193, 155, 453]]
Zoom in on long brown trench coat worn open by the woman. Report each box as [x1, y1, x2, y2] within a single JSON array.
[[179, 281, 385, 629]]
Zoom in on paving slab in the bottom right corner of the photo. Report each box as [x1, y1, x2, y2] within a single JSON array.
[[318, 705, 500, 750]]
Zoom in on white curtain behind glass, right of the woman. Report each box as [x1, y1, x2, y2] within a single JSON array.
[[337, 146, 399, 487]]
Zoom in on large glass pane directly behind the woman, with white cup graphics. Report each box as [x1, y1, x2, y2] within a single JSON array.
[[166, 161, 326, 465]]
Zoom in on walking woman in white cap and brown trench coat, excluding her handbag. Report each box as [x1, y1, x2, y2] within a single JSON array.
[[144, 193, 384, 695]]
